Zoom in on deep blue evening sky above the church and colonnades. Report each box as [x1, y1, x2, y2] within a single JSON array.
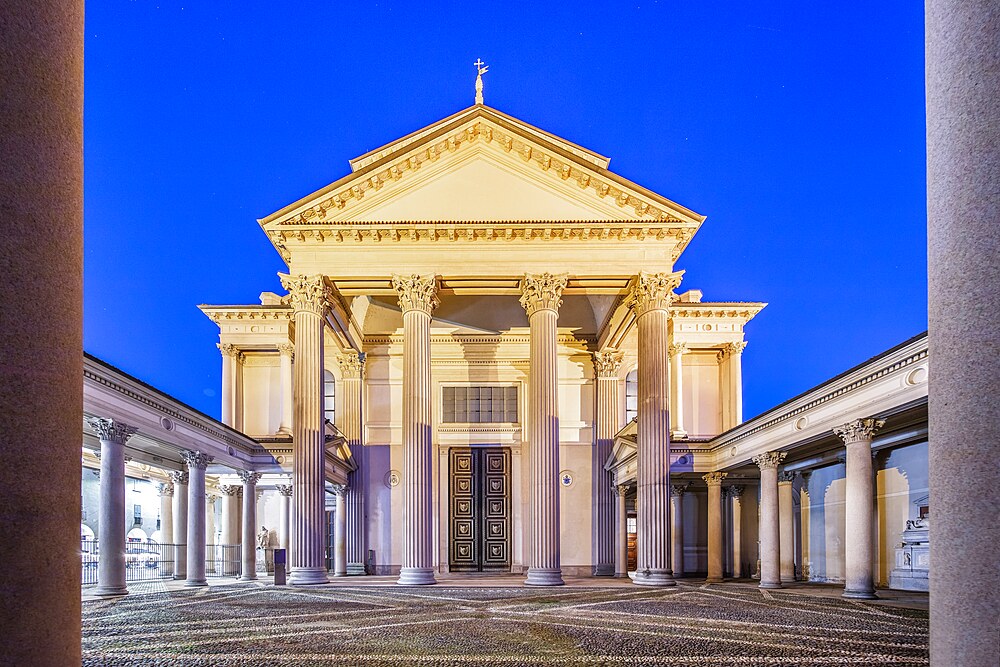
[[84, 0, 927, 417]]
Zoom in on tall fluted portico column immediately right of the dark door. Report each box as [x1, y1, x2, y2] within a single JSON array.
[[521, 273, 566, 586]]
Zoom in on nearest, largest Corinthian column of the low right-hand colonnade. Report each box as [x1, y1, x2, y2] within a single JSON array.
[[833, 419, 885, 600]]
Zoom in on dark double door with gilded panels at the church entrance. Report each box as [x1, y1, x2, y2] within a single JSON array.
[[448, 447, 511, 572]]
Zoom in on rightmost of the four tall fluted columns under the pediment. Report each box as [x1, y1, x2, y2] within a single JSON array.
[[629, 272, 683, 586]]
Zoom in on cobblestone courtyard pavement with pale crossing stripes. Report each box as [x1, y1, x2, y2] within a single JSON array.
[[83, 583, 928, 667]]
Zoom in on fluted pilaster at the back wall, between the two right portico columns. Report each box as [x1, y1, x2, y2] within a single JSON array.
[[593, 350, 622, 577]]
